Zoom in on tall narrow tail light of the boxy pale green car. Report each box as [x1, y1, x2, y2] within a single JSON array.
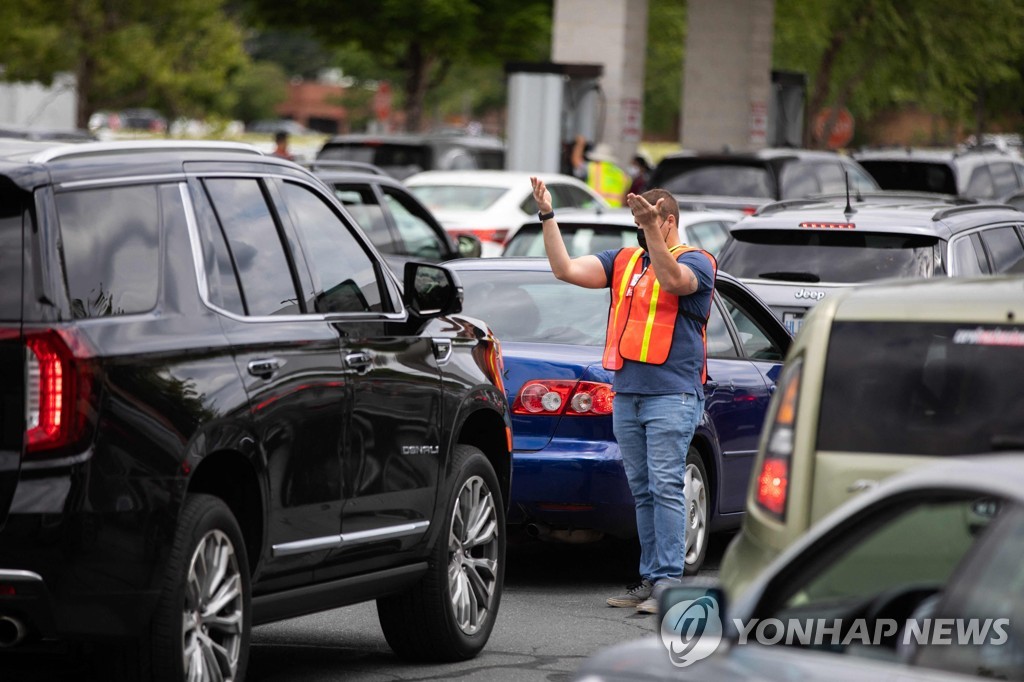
[[757, 359, 803, 521]]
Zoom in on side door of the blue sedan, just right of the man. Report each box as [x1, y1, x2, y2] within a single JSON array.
[[705, 280, 790, 513]]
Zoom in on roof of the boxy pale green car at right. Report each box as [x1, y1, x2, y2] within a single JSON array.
[[816, 274, 1024, 323]]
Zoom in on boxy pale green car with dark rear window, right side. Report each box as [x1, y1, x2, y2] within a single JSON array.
[[720, 275, 1024, 598]]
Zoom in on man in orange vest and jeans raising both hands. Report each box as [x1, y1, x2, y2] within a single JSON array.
[[530, 177, 718, 613]]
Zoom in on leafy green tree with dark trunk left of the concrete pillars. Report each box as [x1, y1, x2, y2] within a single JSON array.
[[248, 0, 553, 130]]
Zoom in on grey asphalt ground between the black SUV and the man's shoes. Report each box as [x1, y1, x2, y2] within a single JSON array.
[[248, 537, 728, 682]]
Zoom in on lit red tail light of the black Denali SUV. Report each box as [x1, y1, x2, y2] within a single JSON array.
[[25, 330, 91, 453]]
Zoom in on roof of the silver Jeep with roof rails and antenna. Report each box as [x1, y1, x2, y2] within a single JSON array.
[[731, 195, 1024, 239]]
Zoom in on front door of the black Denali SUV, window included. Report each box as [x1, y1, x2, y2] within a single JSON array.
[[279, 180, 451, 577]]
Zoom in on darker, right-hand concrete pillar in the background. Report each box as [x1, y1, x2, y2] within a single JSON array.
[[680, 0, 775, 151]]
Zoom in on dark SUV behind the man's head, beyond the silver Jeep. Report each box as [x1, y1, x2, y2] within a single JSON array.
[[647, 148, 879, 214]]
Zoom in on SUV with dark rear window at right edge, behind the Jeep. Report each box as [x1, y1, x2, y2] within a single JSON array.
[[854, 146, 1024, 201]]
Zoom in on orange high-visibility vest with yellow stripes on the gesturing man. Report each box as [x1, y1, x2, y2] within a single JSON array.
[[601, 244, 718, 381]]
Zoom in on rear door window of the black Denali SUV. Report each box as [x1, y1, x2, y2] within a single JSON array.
[[197, 179, 301, 315]]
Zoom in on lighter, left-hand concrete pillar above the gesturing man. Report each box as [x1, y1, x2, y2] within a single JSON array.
[[551, 0, 647, 168]]
